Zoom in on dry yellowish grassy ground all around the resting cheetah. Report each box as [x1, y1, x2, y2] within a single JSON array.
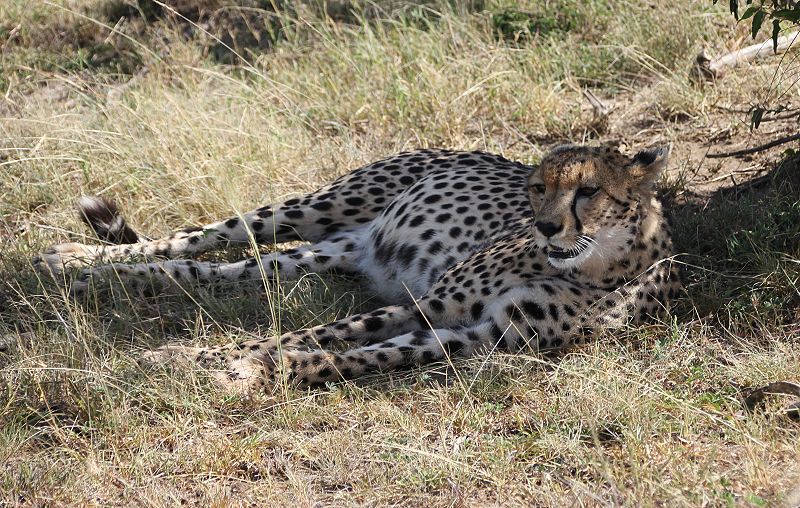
[[0, 0, 800, 506]]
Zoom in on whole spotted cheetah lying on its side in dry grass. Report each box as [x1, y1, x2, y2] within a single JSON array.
[[34, 145, 679, 391]]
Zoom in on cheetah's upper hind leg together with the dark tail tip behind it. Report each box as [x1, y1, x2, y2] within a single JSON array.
[[33, 154, 431, 274]]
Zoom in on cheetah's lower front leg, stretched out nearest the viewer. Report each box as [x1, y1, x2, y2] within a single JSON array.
[[178, 278, 630, 390]]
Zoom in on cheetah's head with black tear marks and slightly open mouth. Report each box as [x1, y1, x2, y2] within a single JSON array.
[[528, 145, 669, 270]]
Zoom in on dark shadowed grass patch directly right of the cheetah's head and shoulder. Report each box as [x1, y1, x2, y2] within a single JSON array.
[[671, 154, 800, 336]]
